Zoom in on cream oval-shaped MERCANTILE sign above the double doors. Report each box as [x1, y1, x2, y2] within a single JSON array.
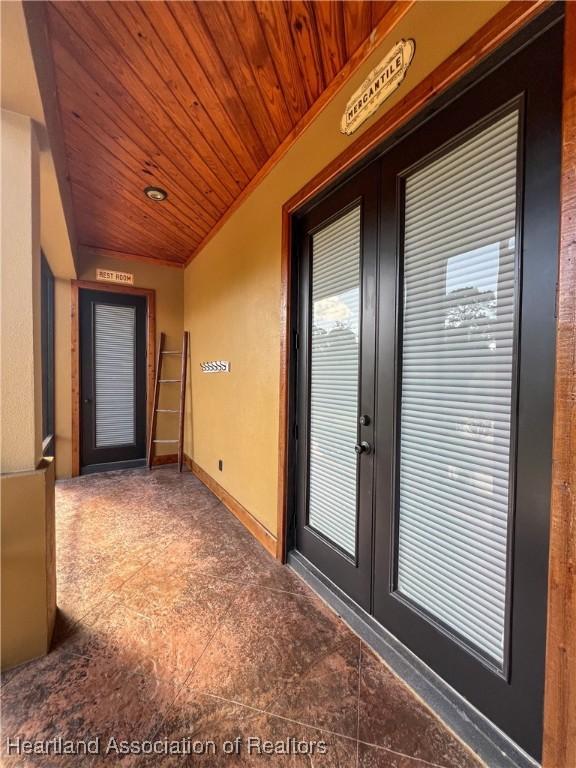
[[340, 40, 416, 136]]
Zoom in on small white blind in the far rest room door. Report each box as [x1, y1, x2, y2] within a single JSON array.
[[94, 304, 136, 448]]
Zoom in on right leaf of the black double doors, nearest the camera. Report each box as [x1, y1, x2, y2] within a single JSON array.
[[373, 24, 562, 758]]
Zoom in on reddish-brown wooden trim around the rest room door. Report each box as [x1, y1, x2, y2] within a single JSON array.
[[70, 280, 156, 477]]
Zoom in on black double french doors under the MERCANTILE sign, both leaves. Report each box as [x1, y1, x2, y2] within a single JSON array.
[[295, 18, 562, 758]]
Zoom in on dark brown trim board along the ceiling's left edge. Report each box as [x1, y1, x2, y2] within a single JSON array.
[[22, 0, 78, 271]]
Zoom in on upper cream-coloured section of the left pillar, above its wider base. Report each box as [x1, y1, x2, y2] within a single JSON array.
[[0, 109, 42, 472]]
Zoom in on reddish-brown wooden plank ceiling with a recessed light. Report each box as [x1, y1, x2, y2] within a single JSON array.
[[47, 0, 394, 265]]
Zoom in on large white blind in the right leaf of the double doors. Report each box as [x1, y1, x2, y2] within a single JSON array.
[[398, 112, 518, 664]]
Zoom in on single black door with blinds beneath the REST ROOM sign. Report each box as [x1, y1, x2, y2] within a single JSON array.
[[80, 289, 146, 472]]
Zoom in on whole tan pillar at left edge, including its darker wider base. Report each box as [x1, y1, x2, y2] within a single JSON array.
[[0, 109, 56, 669]]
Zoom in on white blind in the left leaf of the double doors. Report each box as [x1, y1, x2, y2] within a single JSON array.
[[308, 207, 360, 555]]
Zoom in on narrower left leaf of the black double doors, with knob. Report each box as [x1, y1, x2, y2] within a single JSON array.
[[296, 169, 377, 607]]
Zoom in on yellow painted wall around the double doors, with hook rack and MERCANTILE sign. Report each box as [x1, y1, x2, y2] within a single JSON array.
[[184, 2, 505, 534]]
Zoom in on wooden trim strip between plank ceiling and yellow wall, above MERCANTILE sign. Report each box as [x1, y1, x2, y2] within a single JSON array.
[[184, 0, 416, 266]]
